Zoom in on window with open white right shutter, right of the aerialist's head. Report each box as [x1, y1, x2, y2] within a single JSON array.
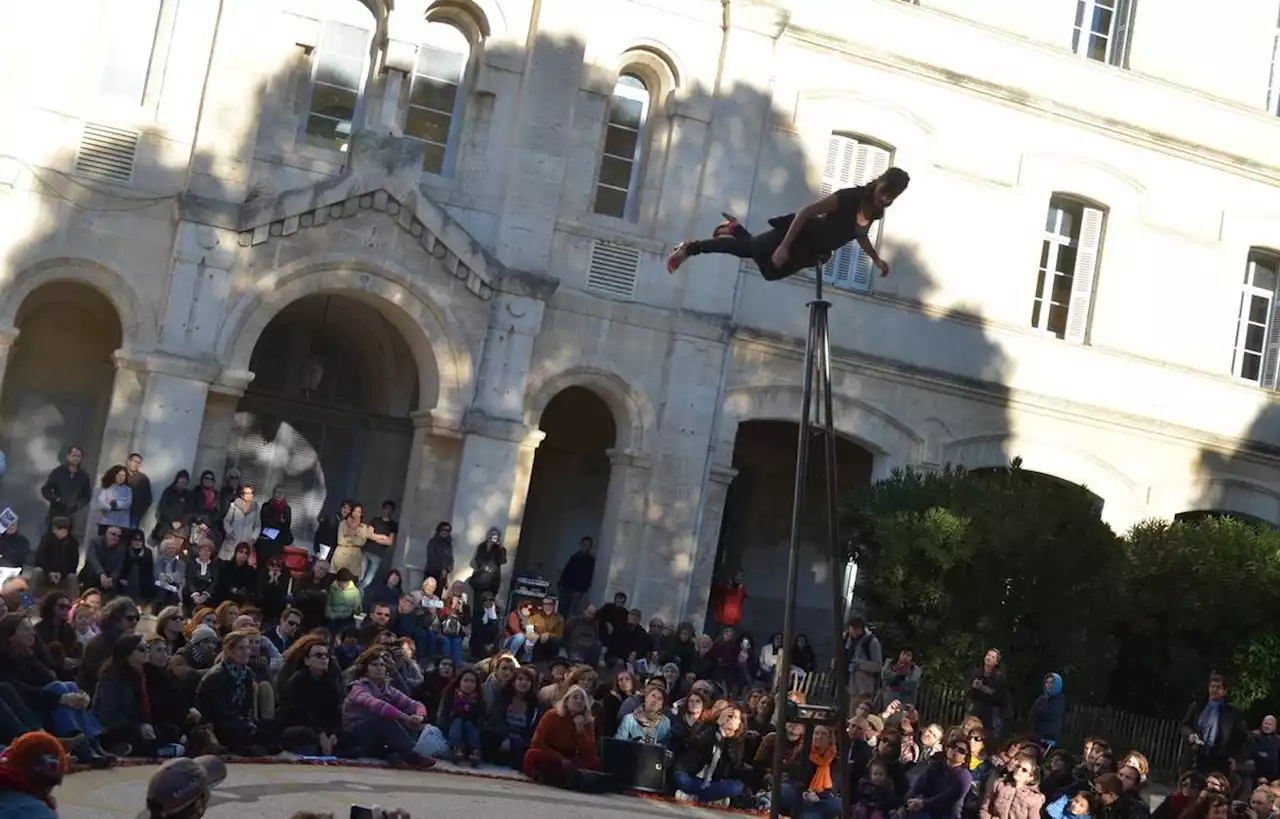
[[1032, 193, 1106, 344]]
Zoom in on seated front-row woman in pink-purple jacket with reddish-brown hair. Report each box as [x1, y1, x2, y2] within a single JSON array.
[[340, 644, 435, 770]]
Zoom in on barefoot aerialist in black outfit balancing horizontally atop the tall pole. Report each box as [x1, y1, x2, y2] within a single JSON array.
[[667, 168, 911, 282]]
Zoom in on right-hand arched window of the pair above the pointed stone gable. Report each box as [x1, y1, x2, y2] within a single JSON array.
[[404, 20, 471, 174]]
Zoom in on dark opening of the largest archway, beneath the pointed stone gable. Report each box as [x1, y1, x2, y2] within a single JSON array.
[[219, 294, 419, 544]]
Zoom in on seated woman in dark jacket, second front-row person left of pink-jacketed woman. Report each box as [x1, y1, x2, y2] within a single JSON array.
[[193, 628, 271, 756]]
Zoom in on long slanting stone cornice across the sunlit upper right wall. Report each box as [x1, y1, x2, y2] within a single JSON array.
[[786, 23, 1280, 184]]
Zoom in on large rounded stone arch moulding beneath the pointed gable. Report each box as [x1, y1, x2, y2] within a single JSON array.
[[216, 255, 475, 427]]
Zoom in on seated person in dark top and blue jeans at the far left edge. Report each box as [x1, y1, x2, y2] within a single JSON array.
[[0, 614, 114, 765]]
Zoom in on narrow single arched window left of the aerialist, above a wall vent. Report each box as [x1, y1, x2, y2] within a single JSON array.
[[595, 74, 650, 219]]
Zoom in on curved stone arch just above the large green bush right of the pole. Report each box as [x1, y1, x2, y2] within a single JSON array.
[[943, 434, 1143, 526]]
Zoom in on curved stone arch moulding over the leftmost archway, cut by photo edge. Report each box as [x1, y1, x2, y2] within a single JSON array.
[[0, 257, 157, 352]]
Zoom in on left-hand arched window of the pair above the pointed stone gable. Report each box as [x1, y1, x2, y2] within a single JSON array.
[[306, 0, 374, 151]]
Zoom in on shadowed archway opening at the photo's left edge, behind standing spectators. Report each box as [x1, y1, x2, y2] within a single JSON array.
[[0, 280, 123, 543]]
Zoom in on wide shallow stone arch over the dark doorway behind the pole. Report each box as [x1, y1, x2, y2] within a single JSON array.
[[716, 385, 924, 476]]
